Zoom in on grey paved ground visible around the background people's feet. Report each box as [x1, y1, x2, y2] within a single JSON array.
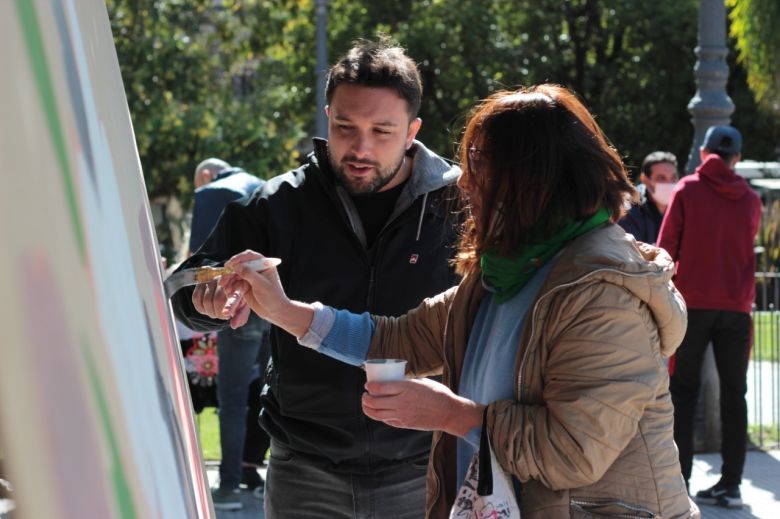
[[206, 450, 780, 519]]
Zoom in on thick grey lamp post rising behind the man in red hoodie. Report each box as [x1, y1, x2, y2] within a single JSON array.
[[685, 0, 734, 173]]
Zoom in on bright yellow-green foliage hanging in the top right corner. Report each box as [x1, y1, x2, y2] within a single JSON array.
[[726, 0, 780, 113]]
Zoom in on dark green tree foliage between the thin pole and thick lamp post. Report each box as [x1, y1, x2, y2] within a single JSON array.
[[280, 0, 697, 175]]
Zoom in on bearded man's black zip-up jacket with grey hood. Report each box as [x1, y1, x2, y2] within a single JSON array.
[[172, 139, 460, 473]]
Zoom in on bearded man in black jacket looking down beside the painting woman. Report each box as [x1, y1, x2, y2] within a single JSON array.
[[172, 38, 460, 519]]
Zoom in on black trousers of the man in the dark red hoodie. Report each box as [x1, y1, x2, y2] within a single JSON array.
[[669, 309, 752, 485]]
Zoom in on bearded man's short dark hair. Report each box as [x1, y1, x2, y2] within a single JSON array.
[[325, 38, 422, 119]]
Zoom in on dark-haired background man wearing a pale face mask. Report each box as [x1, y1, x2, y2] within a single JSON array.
[[618, 151, 679, 245]]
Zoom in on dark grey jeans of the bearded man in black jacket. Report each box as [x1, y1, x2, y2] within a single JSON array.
[[264, 439, 426, 519]]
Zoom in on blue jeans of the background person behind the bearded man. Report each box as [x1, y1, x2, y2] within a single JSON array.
[[217, 314, 270, 489]]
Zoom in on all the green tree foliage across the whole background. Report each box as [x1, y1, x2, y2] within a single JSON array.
[[106, 0, 780, 204]]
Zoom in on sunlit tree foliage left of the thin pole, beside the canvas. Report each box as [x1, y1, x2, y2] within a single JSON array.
[[107, 0, 304, 201]]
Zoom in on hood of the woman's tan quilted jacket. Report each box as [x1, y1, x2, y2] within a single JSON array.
[[540, 224, 687, 357]]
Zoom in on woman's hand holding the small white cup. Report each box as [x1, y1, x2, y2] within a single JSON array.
[[363, 378, 485, 437]]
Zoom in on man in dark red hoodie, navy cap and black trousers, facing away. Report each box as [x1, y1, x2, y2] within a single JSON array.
[[658, 126, 761, 507]]
